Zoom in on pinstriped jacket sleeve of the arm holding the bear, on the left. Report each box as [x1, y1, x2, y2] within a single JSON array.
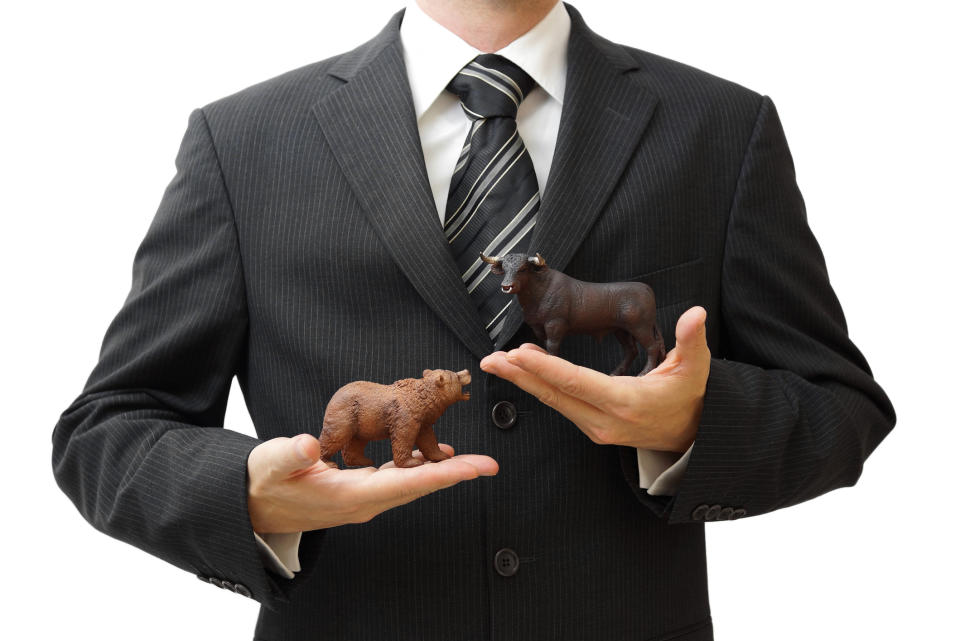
[[52, 109, 318, 608]]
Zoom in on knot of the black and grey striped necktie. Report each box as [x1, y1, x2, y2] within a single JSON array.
[[447, 53, 536, 120]]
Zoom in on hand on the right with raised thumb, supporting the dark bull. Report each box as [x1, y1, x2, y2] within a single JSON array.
[[480, 306, 710, 452]]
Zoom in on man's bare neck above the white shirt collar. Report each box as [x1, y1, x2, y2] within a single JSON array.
[[416, 0, 557, 53]]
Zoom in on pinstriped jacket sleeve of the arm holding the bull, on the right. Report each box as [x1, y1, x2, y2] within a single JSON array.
[[634, 96, 896, 523]]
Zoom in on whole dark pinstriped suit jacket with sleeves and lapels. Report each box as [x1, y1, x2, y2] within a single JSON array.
[[53, 7, 895, 641]]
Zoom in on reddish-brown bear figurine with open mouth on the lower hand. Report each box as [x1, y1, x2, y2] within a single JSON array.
[[320, 369, 470, 467]]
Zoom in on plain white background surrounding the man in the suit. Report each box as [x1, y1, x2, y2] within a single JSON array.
[[0, 0, 960, 641]]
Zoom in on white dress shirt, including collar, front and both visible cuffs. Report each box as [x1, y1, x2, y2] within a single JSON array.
[[257, 2, 692, 578]]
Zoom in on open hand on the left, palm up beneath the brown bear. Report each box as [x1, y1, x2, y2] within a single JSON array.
[[247, 434, 499, 534]]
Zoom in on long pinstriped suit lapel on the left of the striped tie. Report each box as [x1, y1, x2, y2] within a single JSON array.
[[313, 11, 493, 358]]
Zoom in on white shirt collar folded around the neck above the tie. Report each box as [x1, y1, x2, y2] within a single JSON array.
[[400, 0, 570, 120]]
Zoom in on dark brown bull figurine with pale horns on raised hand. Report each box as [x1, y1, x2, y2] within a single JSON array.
[[480, 254, 666, 376]]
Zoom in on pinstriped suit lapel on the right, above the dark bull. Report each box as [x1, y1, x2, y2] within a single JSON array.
[[496, 5, 658, 349]]
